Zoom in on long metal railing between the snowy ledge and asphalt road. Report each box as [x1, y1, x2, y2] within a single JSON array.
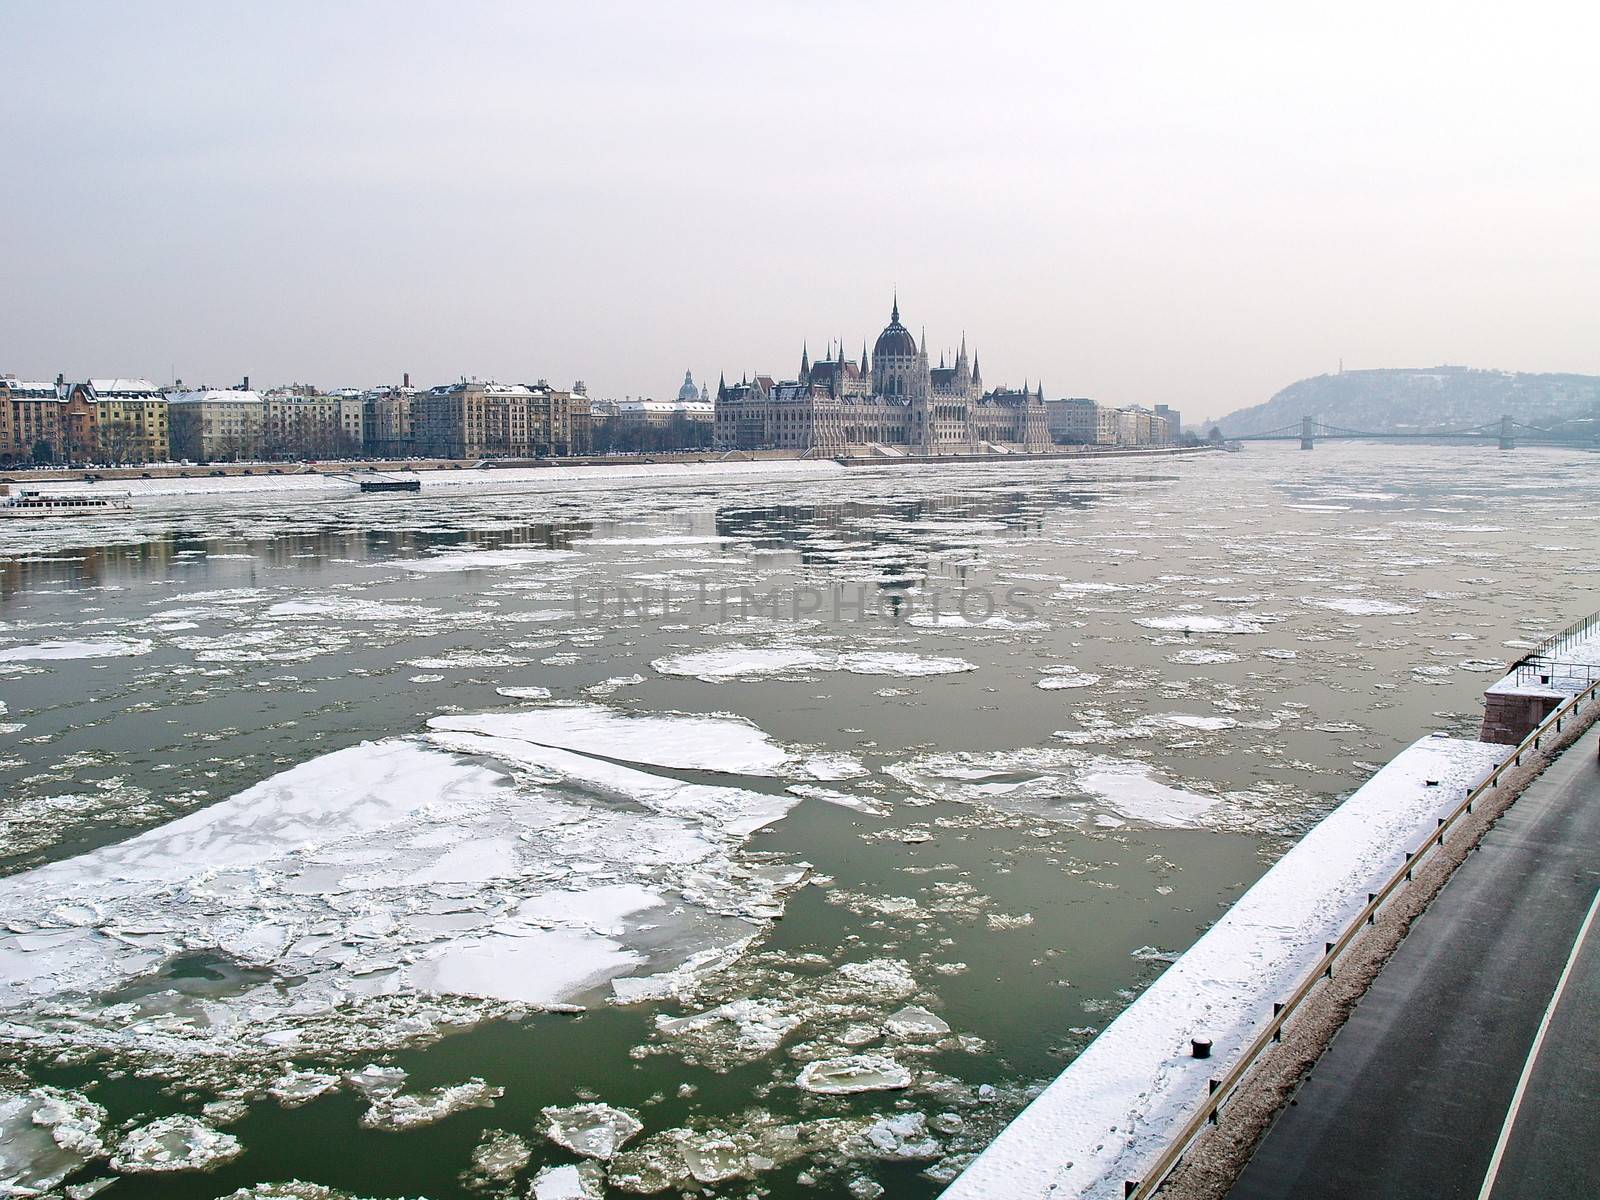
[[1123, 678, 1600, 1200]]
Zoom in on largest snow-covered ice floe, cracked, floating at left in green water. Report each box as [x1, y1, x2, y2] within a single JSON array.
[[0, 704, 829, 1058]]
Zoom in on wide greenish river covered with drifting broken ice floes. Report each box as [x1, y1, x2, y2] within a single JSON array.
[[0, 445, 1600, 1200]]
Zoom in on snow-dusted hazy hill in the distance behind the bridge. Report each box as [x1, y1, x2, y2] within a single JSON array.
[[1216, 366, 1600, 437]]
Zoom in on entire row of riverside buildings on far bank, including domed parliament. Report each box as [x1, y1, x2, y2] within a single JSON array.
[[0, 316, 1182, 466]]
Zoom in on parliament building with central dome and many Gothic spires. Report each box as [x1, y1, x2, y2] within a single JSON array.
[[715, 296, 1051, 454]]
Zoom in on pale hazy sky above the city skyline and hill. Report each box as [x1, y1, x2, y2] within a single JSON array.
[[0, 0, 1600, 416]]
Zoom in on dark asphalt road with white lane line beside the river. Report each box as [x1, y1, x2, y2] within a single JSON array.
[[1230, 734, 1600, 1200]]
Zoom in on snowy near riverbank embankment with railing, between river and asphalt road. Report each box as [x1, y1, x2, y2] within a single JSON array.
[[946, 622, 1600, 1200]]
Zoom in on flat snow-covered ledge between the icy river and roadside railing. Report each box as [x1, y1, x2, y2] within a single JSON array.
[[942, 734, 1510, 1200]]
